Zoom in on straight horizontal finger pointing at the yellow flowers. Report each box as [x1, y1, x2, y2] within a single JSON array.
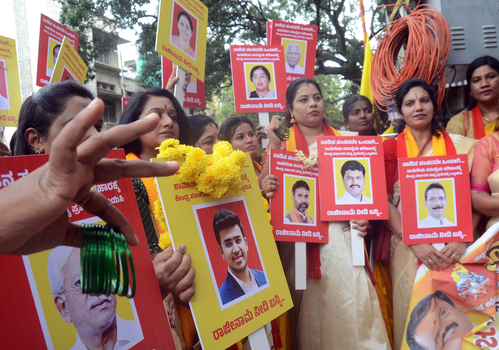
[[94, 159, 179, 183]]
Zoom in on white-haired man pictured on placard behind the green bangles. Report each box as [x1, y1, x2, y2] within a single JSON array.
[[47, 246, 144, 350]]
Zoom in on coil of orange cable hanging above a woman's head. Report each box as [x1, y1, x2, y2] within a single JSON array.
[[371, 5, 450, 112]]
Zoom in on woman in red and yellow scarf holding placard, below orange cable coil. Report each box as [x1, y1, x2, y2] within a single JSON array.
[[384, 78, 476, 349]]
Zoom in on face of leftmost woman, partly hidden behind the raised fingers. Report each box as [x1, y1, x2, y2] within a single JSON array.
[[41, 96, 97, 153]]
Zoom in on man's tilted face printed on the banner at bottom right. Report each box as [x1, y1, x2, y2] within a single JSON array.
[[405, 290, 474, 350]]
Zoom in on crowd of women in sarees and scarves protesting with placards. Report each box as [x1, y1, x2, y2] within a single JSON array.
[[0, 52, 499, 349]]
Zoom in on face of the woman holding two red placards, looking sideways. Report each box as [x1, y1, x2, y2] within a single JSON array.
[[290, 84, 324, 127]]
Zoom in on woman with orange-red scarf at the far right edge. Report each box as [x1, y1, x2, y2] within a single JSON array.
[[446, 56, 499, 140]]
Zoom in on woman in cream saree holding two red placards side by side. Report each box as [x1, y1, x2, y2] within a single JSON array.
[[260, 78, 390, 349]]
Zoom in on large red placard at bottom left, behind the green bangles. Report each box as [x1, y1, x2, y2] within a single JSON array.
[[0, 150, 175, 350]]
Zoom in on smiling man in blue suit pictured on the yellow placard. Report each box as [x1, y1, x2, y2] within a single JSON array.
[[213, 209, 267, 304]]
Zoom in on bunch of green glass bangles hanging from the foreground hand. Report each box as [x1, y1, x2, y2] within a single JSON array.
[[80, 225, 136, 298]]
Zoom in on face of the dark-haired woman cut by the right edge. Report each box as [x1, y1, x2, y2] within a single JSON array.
[[470, 65, 499, 103]]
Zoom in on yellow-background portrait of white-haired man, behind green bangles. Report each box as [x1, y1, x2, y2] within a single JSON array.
[[25, 246, 144, 350]]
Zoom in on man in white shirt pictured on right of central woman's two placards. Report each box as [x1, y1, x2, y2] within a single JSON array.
[[336, 160, 373, 204]]
